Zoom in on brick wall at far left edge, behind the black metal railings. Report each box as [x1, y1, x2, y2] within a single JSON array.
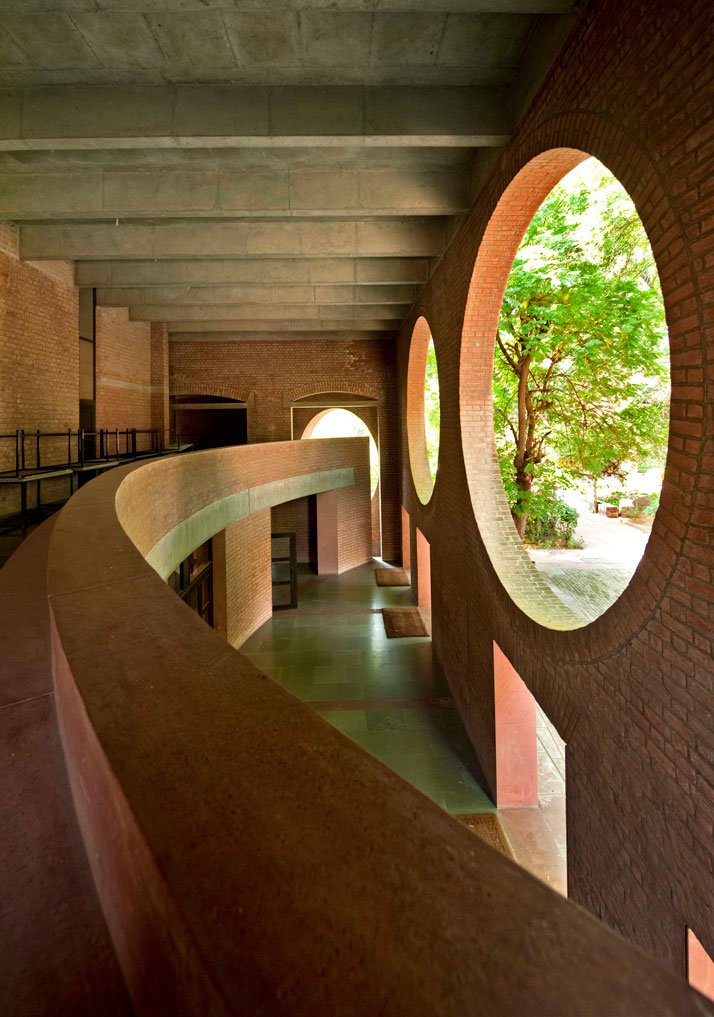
[[0, 230, 79, 515]]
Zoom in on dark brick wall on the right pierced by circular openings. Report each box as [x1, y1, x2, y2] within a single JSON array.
[[399, 0, 714, 973]]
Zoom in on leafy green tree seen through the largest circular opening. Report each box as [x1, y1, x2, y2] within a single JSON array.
[[493, 160, 667, 537]]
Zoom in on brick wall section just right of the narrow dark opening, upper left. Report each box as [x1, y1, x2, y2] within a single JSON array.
[[95, 307, 152, 441]]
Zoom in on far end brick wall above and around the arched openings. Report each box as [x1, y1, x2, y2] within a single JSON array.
[[170, 340, 401, 559]]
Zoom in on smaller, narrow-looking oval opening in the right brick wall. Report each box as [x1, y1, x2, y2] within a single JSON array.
[[407, 317, 440, 504]]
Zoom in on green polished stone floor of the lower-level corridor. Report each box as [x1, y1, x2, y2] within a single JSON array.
[[240, 561, 494, 815]]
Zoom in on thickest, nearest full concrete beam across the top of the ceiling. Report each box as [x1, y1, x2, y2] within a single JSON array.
[[0, 85, 512, 152]]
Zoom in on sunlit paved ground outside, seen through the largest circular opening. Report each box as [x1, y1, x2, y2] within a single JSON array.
[[529, 509, 649, 621]]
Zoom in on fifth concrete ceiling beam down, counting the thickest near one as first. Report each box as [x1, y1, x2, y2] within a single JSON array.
[[97, 285, 418, 308]]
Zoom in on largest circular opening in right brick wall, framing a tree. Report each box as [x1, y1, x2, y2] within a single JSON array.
[[461, 149, 669, 629]]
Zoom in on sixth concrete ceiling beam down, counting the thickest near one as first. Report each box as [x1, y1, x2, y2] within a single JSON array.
[[129, 304, 411, 327]]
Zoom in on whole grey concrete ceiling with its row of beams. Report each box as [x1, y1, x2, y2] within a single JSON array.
[[0, 0, 579, 341]]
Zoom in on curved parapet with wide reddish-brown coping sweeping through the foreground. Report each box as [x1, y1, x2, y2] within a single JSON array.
[[36, 439, 707, 1017]]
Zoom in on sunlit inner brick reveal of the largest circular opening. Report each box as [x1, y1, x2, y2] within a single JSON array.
[[461, 147, 674, 634]]
